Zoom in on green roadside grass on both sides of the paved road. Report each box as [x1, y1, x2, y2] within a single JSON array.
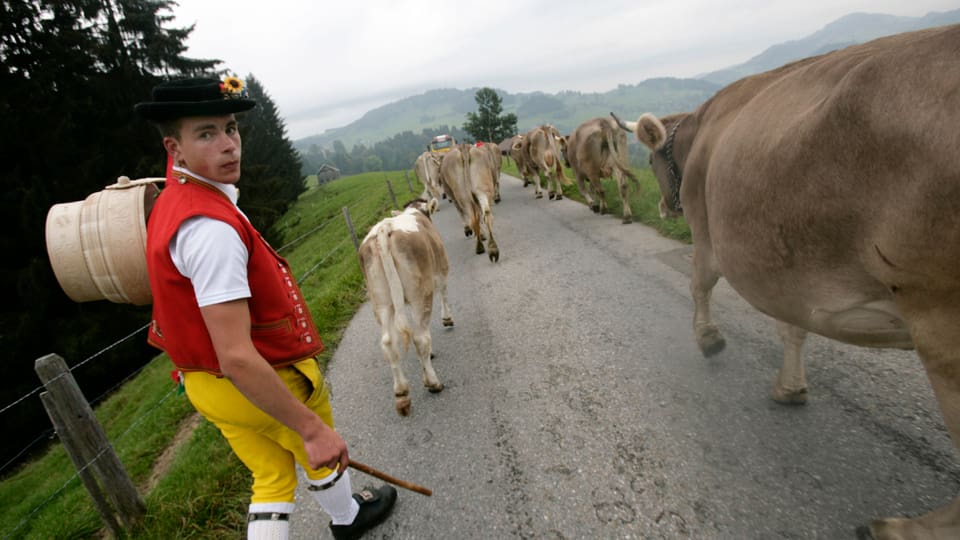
[[0, 167, 690, 540]]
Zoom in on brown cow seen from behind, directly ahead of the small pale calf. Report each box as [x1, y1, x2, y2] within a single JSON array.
[[440, 144, 500, 262]]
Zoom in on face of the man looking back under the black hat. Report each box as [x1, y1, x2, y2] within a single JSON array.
[[163, 114, 240, 184]]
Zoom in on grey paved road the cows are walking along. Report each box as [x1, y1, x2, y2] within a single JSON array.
[[292, 176, 960, 540]]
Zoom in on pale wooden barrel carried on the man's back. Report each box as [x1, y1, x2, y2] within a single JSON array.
[[46, 176, 164, 305]]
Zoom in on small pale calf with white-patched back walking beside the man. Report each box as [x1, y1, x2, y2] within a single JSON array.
[[359, 199, 453, 416]]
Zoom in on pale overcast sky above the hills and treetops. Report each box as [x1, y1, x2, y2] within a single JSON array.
[[172, 0, 960, 140]]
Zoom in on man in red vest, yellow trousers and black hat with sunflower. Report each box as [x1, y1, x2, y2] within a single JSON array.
[[136, 77, 397, 539]]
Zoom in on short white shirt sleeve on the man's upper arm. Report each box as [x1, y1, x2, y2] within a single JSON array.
[[170, 216, 251, 307]]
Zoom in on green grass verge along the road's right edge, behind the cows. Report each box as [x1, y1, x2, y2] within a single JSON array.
[[503, 160, 691, 243]]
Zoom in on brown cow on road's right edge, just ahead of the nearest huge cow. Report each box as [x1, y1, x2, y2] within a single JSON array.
[[564, 118, 640, 223]]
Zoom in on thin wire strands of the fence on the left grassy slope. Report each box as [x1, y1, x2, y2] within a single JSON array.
[[0, 175, 409, 539]]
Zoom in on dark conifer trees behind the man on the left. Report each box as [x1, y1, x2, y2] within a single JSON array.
[[0, 0, 304, 471]]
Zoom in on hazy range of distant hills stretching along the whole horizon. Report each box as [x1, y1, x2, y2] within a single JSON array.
[[293, 9, 960, 152]]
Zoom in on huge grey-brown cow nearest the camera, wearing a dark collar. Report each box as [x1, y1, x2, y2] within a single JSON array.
[[627, 25, 960, 540]]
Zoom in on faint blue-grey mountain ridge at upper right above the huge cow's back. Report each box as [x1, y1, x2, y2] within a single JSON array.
[[699, 9, 960, 86]]
